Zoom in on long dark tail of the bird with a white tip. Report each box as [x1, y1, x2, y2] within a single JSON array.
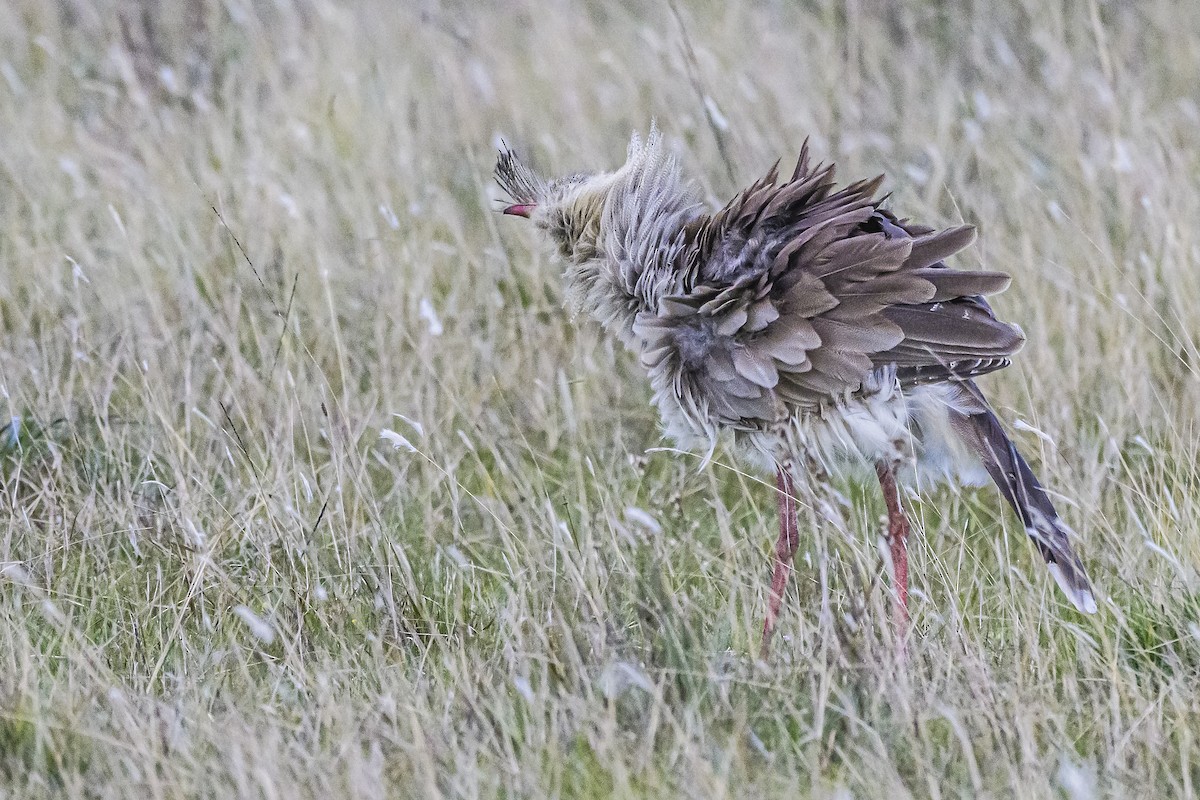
[[950, 393, 1096, 614]]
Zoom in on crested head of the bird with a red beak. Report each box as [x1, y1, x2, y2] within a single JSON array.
[[496, 149, 613, 261]]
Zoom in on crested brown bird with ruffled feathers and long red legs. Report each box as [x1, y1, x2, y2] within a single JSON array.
[[494, 124, 1097, 655]]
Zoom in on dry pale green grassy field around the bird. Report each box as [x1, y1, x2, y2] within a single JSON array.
[[0, 0, 1200, 800]]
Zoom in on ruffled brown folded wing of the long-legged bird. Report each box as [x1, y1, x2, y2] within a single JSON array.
[[635, 143, 1024, 427]]
